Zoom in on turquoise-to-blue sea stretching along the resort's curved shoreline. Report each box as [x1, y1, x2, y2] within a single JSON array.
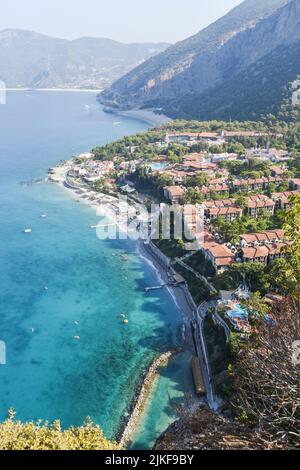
[[0, 92, 182, 446]]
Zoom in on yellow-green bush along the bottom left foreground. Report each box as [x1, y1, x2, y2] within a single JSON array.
[[0, 411, 120, 450]]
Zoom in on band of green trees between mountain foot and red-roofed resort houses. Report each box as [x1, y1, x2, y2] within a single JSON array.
[[92, 119, 300, 167]]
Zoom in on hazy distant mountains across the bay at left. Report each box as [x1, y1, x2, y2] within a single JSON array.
[[0, 29, 168, 89]]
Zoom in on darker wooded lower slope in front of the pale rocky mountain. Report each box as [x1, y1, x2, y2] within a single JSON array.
[[171, 43, 300, 122]]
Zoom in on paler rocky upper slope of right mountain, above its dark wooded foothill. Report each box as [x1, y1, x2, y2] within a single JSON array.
[[99, 0, 300, 118]]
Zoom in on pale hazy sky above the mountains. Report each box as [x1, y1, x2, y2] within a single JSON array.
[[0, 0, 242, 43]]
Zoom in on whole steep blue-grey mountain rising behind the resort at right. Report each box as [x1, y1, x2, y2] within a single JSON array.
[[100, 0, 300, 119]]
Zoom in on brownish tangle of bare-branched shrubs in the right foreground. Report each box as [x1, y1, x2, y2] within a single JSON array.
[[233, 296, 300, 448]]
